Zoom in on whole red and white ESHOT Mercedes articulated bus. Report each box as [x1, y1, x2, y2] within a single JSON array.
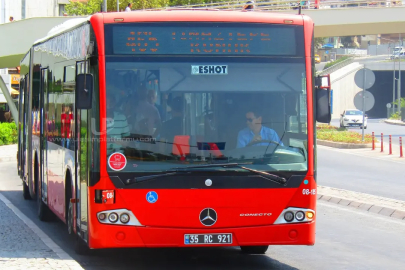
[[17, 10, 330, 254]]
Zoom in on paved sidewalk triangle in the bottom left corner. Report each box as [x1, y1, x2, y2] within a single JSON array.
[[0, 193, 83, 270]]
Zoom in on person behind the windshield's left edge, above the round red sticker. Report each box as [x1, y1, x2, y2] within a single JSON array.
[[107, 94, 130, 154]]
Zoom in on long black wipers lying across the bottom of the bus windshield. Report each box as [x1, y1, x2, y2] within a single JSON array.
[[125, 163, 287, 185]]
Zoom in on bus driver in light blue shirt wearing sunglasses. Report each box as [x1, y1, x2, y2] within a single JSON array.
[[236, 109, 283, 148]]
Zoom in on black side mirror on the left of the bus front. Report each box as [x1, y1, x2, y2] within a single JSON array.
[[76, 74, 93, 110]]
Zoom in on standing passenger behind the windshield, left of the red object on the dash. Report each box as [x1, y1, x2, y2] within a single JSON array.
[[133, 86, 161, 136]]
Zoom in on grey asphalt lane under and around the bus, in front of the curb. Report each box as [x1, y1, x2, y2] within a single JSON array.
[[0, 160, 405, 270]]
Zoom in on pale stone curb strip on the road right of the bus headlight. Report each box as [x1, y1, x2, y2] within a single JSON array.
[[318, 193, 405, 220]]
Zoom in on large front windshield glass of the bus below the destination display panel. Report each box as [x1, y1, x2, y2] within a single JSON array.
[[106, 61, 307, 172]]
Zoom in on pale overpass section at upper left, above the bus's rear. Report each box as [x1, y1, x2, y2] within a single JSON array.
[[0, 17, 84, 69]]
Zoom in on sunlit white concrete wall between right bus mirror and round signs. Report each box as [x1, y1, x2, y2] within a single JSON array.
[[330, 62, 363, 119]]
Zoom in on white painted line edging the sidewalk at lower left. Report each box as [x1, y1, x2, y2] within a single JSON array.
[[0, 193, 83, 270]]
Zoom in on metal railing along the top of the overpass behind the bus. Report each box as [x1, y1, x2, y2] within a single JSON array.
[[149, 0, 402, 11]]
